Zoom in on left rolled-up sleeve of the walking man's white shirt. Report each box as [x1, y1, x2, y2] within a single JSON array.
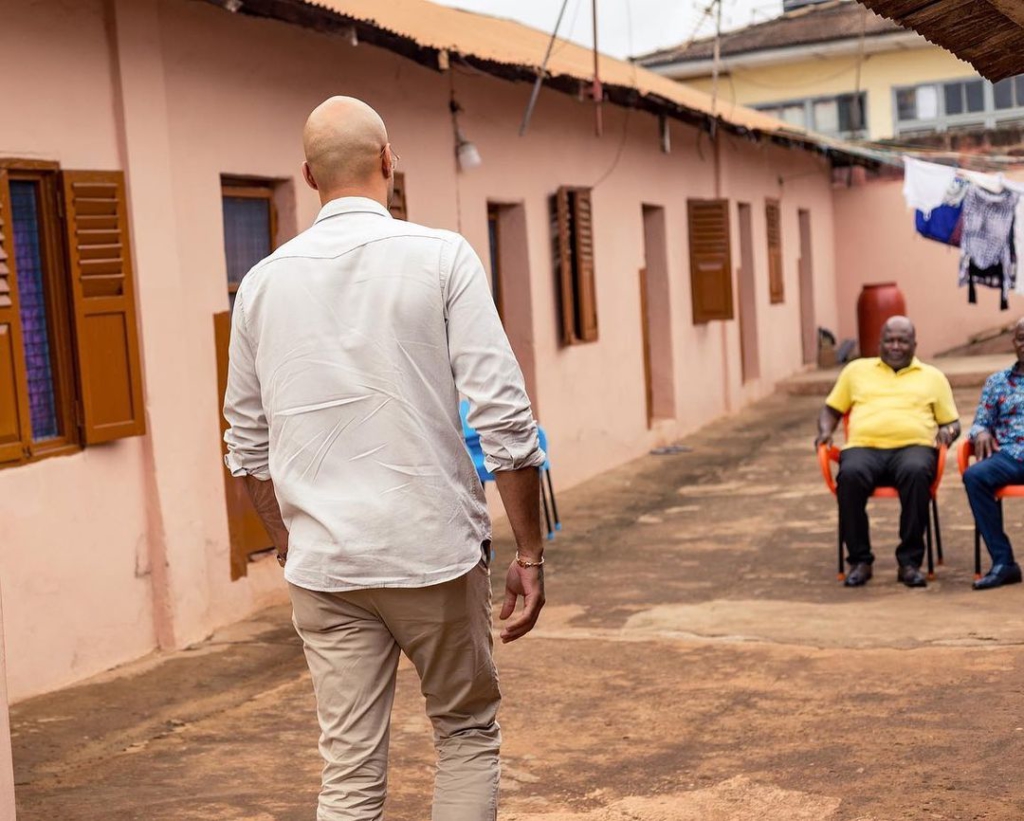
[[224, 288, 270, 481]]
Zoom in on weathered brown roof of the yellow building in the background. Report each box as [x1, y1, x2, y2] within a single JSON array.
[[636, 0, 902, 67]]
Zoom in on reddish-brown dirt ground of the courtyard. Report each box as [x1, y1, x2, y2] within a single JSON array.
[[12, 390, 1024, 821]]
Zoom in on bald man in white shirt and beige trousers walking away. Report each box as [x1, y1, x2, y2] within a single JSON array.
[[224, 97, 544, 821]]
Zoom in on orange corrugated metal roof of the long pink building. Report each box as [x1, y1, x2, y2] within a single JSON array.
[[201, 0, 878, 164]]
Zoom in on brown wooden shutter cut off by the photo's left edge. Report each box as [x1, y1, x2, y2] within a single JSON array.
[[0, 169, 32, 465]]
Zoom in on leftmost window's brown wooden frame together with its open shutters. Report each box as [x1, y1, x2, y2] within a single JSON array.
[[0, 157, 146, 470]]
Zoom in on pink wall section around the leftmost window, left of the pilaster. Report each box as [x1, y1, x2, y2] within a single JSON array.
[[0, 0, 155, 700]]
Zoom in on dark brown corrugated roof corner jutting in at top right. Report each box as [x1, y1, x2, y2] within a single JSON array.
[[860, 0, 1024, 82]]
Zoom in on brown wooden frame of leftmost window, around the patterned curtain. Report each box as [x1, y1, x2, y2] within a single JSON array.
[[0, 159, 84, 460]]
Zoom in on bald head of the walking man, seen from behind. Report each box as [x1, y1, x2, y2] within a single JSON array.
[[302, 97, 392, 201]]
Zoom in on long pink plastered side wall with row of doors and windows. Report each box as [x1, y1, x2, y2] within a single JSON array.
[[0, 0, 836, 698]]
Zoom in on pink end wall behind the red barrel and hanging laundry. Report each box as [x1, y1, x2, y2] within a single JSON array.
[[835, 174, 1024, 357]]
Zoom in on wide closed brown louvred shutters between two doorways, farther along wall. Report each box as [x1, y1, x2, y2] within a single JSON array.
[[686, 200, 733, 323]]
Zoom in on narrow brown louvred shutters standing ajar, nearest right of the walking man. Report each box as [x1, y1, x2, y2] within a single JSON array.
[[552, 186, 597, 345]]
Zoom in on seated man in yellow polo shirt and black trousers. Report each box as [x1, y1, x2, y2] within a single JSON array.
[[814, 316, 961, 588]]
